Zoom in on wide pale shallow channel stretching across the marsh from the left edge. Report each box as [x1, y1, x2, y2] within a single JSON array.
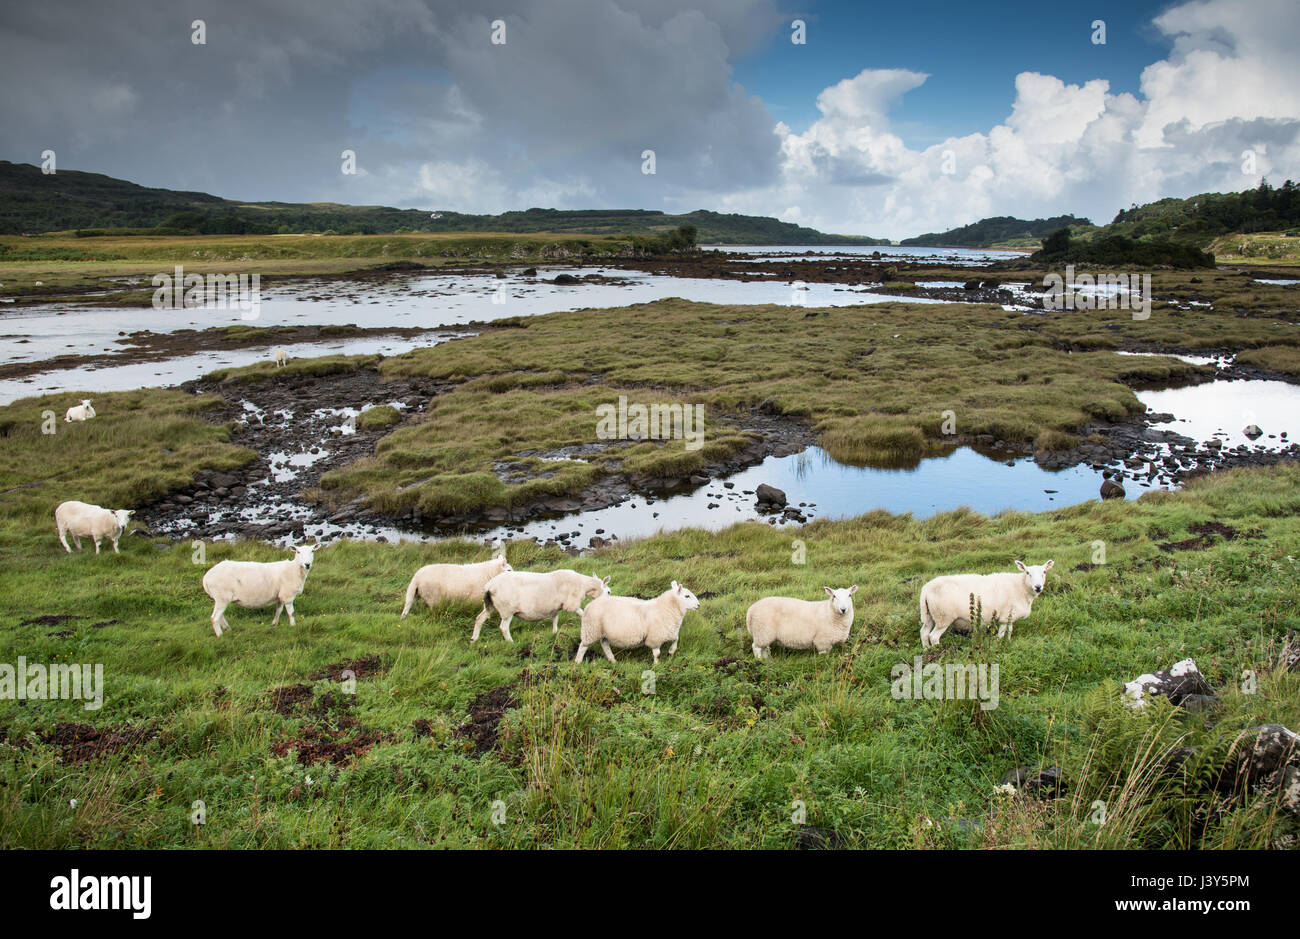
[[0, 262, 941, 404]]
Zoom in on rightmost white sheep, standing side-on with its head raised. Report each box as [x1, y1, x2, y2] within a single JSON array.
[[920, 561, 1056, 649]]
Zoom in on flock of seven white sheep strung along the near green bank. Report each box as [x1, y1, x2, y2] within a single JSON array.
[[55, 502, 1054, 650]]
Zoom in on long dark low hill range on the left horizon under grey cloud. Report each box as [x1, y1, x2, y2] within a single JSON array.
[[0, 160, 889, 245]]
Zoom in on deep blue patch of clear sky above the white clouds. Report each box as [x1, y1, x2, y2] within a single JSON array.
[[735, 0, 1180, 147]]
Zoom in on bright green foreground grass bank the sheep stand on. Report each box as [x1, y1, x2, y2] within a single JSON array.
[[0, 457, 1300, 848]]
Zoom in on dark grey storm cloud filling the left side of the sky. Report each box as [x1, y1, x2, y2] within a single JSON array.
[[0, 0, 783, 211]]
